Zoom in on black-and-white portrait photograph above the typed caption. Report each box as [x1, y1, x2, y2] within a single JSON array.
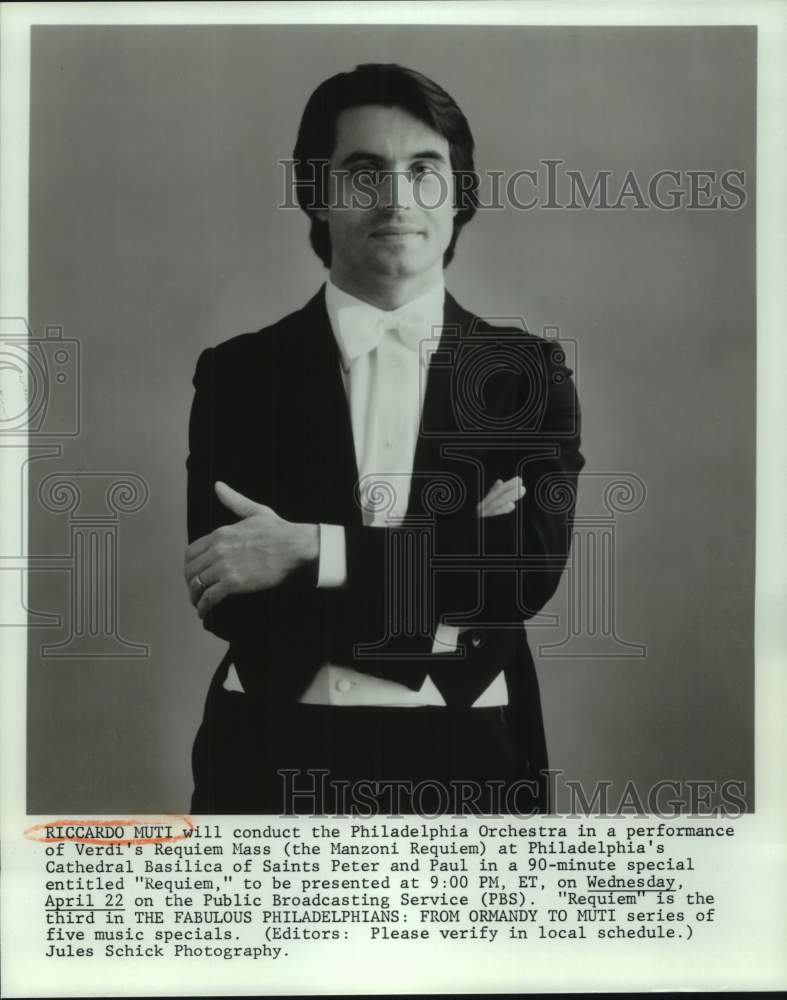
[[20, 19, 756, 814]]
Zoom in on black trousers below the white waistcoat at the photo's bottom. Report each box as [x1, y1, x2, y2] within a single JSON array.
[[191, 671, 548, 816]]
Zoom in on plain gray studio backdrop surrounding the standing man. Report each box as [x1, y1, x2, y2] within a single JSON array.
[[27, 26, 756, 814]]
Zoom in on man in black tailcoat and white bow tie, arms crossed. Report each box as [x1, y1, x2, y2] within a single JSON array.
[[185, 64, 583, 813]]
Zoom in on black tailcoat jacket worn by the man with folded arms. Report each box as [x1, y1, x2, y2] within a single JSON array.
[[187, 286, 584, 762]]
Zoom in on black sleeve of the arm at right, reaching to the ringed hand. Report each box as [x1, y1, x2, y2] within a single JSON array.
[[324, 341, 584, 651]]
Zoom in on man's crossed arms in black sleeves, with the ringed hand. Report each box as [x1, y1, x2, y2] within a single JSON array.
[[184, 342, 584, 643]]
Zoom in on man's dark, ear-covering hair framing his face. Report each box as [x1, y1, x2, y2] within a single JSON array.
[[293, 63, 478, 267]]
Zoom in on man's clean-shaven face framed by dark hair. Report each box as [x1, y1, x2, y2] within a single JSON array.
[[318, 105, 456, 286]]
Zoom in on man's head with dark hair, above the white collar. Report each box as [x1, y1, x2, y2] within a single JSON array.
[[293, 63, 477, 290]]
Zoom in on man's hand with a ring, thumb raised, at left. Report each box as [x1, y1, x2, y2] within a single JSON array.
[[183, 482, 320, 618]]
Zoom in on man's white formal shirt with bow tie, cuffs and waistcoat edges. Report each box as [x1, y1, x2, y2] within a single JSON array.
[[224, 280, 508, 708]]
